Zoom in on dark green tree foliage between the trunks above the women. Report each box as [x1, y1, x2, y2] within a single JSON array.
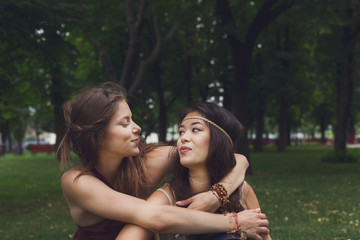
[[0, 0, 360, 154]]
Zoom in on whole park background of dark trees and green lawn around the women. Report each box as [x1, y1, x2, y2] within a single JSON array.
[[0, 0, 360, 239]]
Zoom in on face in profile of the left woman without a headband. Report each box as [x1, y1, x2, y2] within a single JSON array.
[[101, 101, 141, 158]]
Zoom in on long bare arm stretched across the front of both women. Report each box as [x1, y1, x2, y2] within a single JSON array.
[[61, 171, 268, 238]]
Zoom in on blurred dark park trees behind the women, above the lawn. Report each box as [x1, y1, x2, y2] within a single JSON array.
[[0, 0, 360, 161]]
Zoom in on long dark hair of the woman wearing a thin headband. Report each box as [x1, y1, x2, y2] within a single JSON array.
[[171, 102, 244, 212]]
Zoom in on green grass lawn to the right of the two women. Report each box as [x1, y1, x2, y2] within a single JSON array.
[[247, 145, 360, 240]]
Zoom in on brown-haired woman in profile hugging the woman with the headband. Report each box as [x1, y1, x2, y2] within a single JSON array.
[[59, 84, 267, 240]]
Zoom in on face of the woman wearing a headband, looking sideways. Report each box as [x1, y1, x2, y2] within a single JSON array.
[[177, 112, 210, 168]]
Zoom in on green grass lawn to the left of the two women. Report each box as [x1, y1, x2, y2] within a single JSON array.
[[0, 154, 76, 240]]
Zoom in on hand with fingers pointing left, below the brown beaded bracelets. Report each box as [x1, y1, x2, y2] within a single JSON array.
[[176, 191, 220, 213]]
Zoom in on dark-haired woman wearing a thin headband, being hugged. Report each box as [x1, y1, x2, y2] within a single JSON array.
[[117, 103, 271, 240]]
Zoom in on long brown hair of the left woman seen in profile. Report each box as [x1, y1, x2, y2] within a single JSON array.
[[58, 83, 147, 197]]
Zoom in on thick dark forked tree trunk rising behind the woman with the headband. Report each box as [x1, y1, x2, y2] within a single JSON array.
[[216, 0, 290, 174]]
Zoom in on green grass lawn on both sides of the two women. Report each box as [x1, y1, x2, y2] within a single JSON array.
[[0, 144, 360, 240]]
